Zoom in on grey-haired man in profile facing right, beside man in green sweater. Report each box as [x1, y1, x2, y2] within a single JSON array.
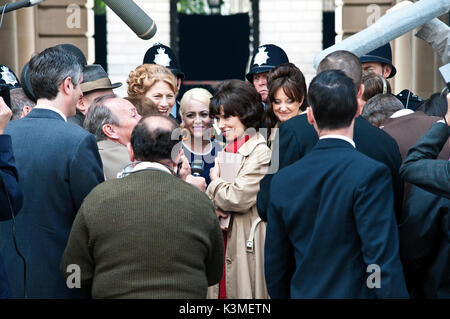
[[84, 94, 141, 180]]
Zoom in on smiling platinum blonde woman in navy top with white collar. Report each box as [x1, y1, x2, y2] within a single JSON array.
[[180, 88, 222, 185]]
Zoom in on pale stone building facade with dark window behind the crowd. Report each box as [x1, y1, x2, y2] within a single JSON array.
[[0, 0, 448, 98]]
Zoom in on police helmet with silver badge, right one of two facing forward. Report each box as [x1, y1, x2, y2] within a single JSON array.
[[246, 44, 289, 82]]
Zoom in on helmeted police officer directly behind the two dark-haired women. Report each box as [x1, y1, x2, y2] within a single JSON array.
[[246, 44, 289, 103]]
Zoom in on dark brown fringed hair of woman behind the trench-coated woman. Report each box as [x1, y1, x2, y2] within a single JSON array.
[[265, 63, 308, 133]]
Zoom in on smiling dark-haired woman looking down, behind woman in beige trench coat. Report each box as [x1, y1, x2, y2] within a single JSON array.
[[265, 63, 308, 146]]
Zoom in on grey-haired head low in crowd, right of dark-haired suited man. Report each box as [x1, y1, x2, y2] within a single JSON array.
[[361, 94, 406, 128]]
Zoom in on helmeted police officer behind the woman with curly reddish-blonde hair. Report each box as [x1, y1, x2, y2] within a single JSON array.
[[142, 43, 184, 123]]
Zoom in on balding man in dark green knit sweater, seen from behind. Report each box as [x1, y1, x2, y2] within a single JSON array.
[[61, 115, 224, 298]]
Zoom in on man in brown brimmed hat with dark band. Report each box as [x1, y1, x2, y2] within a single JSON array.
[[68, 64, 122, 127]]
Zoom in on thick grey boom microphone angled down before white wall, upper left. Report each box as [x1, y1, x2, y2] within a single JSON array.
[[104, 0, 156, 40]]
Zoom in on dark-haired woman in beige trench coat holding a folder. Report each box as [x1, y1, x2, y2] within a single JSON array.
[[206, 80, 270, 299]]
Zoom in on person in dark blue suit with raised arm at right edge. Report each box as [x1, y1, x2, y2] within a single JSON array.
[[399, 93, 450, 298]]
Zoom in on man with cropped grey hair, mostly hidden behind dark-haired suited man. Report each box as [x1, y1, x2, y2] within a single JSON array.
[[257, 51, 403, 221]]
